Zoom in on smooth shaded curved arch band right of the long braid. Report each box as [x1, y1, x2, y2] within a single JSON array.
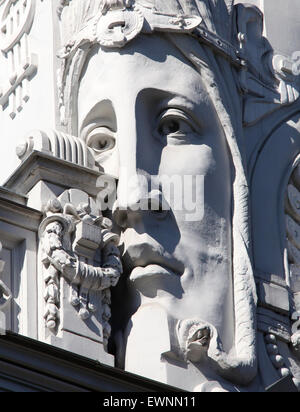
[[251, 113, 300, 283]]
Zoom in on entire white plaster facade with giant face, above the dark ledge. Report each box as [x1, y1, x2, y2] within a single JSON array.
[[0, 0, 300, 392]]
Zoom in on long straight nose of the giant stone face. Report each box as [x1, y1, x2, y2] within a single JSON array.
[[113, 105, 166, 227]]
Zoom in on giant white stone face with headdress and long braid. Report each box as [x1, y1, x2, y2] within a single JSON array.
[[57, 1, 256, 390]]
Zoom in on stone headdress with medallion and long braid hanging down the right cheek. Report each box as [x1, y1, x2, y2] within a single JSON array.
[[59, 0, 257, 383]]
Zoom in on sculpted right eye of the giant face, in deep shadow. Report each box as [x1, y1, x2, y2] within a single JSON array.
[[158, 109, 196, 138]]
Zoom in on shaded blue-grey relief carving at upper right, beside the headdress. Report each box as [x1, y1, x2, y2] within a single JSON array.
[[236, 4, 300, 126]]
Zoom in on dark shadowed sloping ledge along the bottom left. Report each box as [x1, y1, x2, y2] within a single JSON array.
[[0, 332, 181, 392]]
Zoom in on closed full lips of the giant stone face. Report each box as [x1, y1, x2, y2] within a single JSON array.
[[124, 237, 184, 282]]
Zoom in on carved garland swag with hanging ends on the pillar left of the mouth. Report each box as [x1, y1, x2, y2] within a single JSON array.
[[39, 191, 122, 345]]
